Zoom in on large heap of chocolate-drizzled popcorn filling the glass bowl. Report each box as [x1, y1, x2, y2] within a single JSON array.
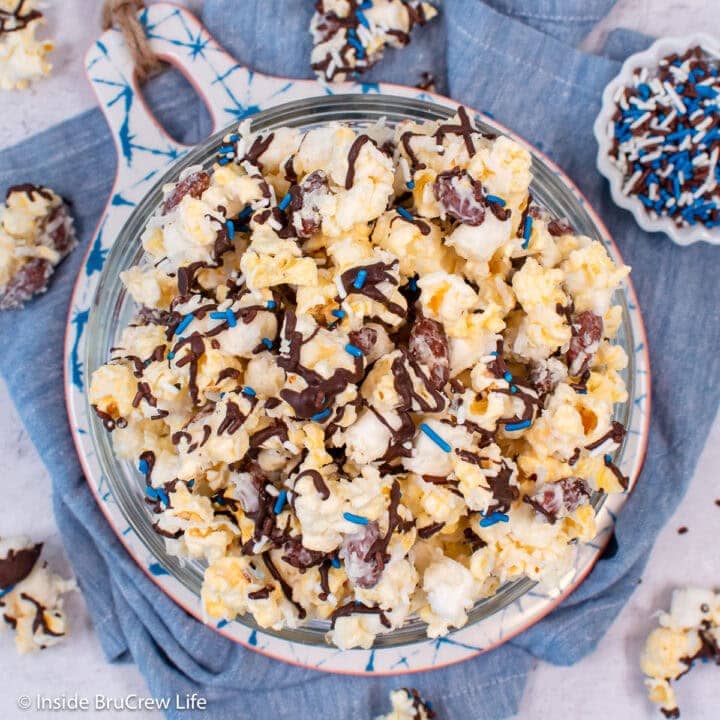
[[90, 108, 629, 648]]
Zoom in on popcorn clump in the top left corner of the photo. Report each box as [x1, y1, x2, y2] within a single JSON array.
[[0, 0, 54, 90]]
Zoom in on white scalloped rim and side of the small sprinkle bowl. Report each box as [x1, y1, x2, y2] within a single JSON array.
[[593, 33, 720, 245]]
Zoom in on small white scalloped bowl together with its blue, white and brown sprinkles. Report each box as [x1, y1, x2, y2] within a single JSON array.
[[594, 34, 720, 245]]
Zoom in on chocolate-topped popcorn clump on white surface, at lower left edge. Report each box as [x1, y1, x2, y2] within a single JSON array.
[[0, 537, 76, 653]]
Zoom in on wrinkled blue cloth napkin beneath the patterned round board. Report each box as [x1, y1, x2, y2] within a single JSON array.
[[0, 0, 720, 720]]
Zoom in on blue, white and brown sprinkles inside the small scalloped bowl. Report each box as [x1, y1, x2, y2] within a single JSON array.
[[608, 47, 720, 228]]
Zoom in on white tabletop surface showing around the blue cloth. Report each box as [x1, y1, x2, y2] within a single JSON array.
[[0, 0, 720, 720]]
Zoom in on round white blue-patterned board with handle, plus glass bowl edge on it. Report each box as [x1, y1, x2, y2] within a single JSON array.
[[65, 4, 650, 674]]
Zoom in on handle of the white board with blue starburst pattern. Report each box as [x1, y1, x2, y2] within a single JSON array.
[[85, 3, 312, 191]]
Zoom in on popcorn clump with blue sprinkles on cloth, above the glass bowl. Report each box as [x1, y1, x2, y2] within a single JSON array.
[[310, 0, 437, 86]]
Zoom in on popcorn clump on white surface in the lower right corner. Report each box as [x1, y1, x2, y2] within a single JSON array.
[[640, 588, 720, 718]]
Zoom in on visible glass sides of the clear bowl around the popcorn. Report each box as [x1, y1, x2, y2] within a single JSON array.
[[83, 95, 637, 647]]
